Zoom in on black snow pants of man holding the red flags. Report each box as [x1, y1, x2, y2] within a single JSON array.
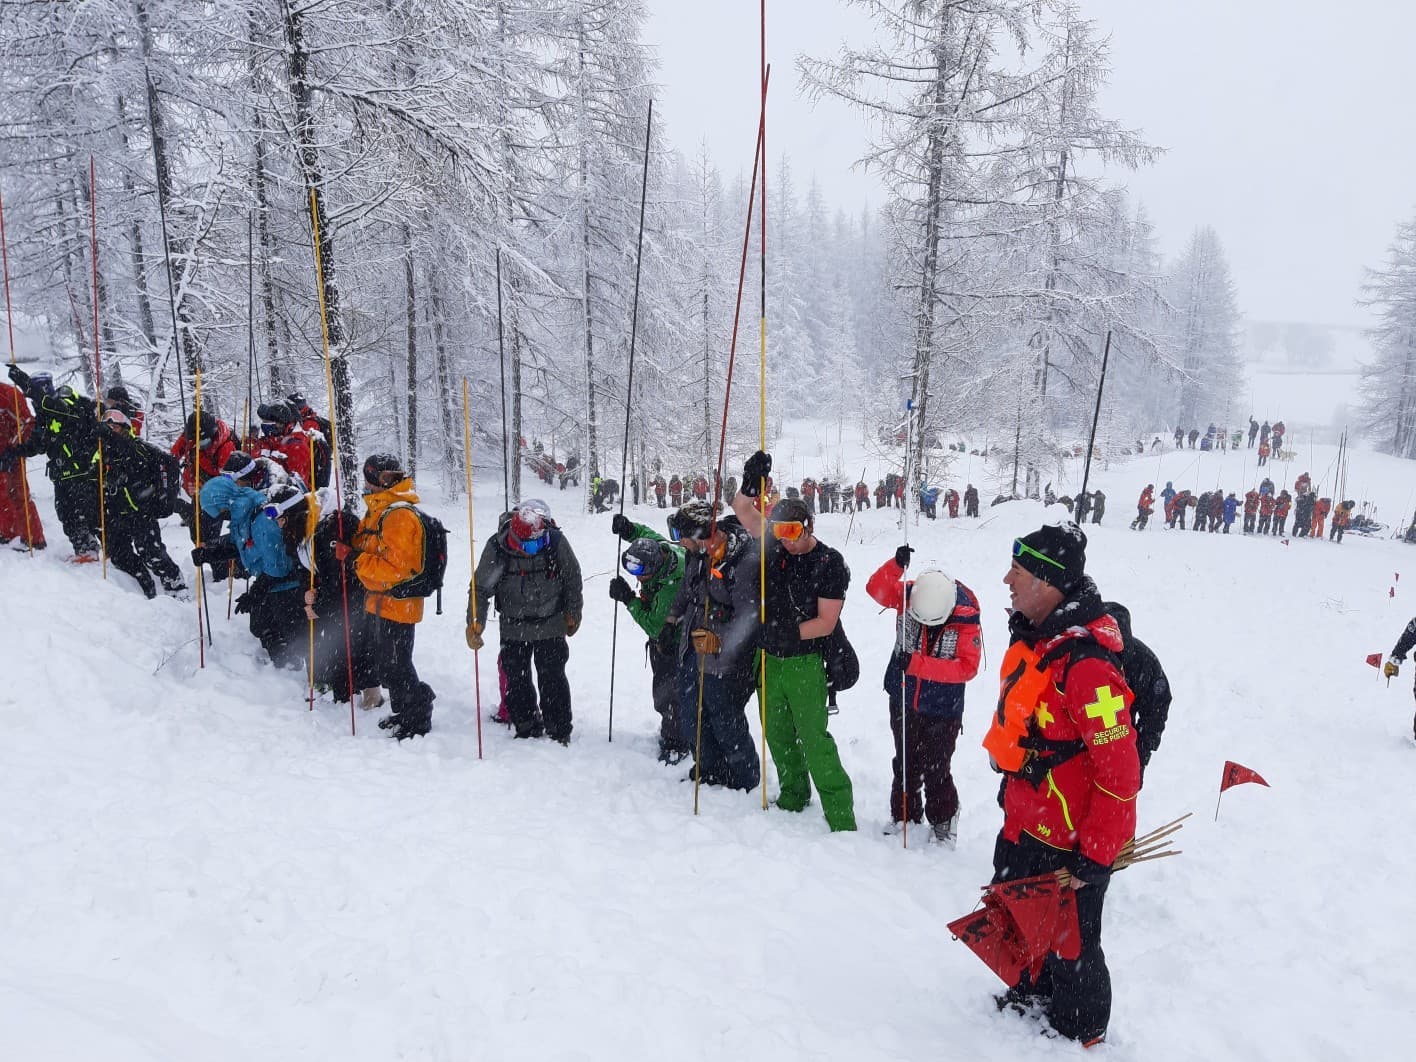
[[993, 834, 1112, 1042]]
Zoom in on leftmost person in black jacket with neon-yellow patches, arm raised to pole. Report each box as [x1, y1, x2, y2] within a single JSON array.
[[4, 365, 99, 564]]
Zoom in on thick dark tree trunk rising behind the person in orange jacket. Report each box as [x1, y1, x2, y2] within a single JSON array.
[[283, 0, 358, 504]]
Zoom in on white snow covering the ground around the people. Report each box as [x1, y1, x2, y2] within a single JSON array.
[[0, 425, 1416, 1062]]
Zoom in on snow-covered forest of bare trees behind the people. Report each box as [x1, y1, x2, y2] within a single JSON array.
[[0, 0, 1285, 509]]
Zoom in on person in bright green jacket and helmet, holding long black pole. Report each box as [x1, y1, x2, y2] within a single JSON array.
[[610, 513, 692, 765]]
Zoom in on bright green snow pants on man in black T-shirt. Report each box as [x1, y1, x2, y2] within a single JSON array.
[[763, 653, 855, 830]]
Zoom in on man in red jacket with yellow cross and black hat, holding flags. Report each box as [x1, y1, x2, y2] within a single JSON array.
[[983, 523, 1141, 1045]]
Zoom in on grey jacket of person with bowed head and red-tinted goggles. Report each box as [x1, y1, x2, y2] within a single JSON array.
[[467, 513, 585, 641]]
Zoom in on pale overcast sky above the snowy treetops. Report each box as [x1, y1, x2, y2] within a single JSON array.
[[646, 0, 1416, 324]]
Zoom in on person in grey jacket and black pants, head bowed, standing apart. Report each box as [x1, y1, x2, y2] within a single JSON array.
[[467, 498, 585, 745]]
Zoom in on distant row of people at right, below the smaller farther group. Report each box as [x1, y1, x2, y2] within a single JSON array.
[[1131, 472, 1357, 542]]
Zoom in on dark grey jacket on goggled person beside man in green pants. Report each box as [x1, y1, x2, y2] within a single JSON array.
[[668, 521, 760, 675]]
